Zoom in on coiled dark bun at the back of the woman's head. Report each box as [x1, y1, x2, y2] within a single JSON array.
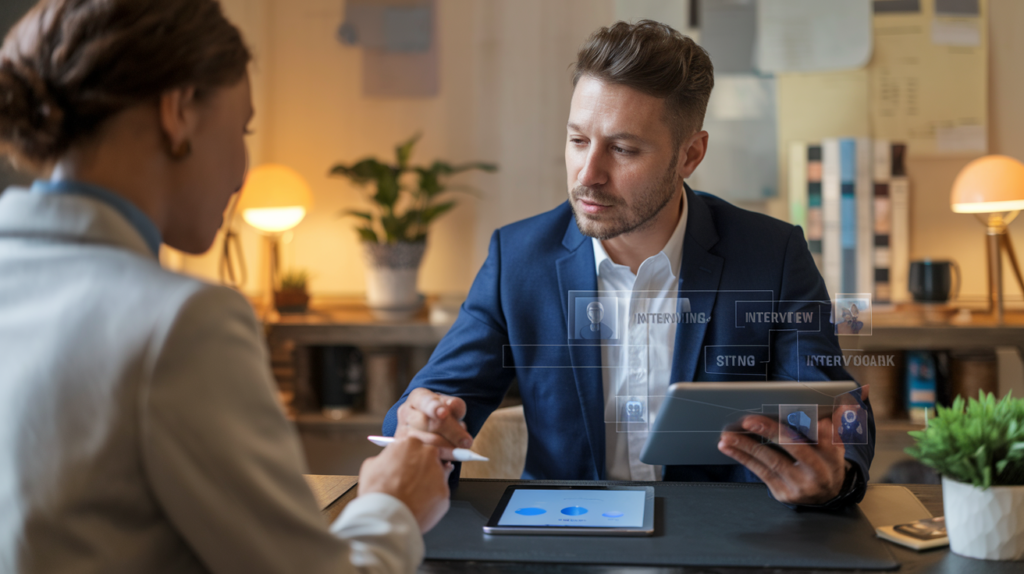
[[0, 59, 65, 164]]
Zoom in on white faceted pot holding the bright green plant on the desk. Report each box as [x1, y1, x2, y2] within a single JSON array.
[[942, 477, 1024, 560]]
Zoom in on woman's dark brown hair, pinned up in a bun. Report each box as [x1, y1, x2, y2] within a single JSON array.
[[0, 0, 250, 169]]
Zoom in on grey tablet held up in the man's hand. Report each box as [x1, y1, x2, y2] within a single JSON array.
[[640, 381, 867, 465]]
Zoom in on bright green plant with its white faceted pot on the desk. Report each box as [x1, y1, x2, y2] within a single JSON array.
[[906, 392, 1024, 560]]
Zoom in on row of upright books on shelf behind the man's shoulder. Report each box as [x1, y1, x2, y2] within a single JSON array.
[[788, 138, 910, 304]]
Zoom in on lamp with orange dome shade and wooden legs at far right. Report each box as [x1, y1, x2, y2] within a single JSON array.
[[949, 156, 1024, 324]]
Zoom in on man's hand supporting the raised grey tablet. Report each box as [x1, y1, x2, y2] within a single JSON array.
[[718, 415, 847, 504]]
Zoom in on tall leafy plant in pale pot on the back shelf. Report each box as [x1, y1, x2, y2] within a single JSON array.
[[331, 135, 498, 320]]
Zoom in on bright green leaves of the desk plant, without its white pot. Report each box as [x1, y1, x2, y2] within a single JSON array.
[[906, 391, 1024, 489]]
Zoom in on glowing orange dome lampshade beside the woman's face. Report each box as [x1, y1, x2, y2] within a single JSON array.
[[239, 164, 313, 233]]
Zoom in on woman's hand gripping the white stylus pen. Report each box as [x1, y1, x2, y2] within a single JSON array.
[[358, 438, 453, 532]]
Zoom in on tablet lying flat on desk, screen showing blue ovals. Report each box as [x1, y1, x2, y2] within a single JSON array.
[[483, 485, 654, 536]]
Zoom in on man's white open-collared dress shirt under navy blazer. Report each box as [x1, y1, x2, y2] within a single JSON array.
[[592, 198, 689, 481]]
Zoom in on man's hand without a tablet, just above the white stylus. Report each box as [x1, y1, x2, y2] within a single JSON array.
[[394, 387, 473, 460]]
